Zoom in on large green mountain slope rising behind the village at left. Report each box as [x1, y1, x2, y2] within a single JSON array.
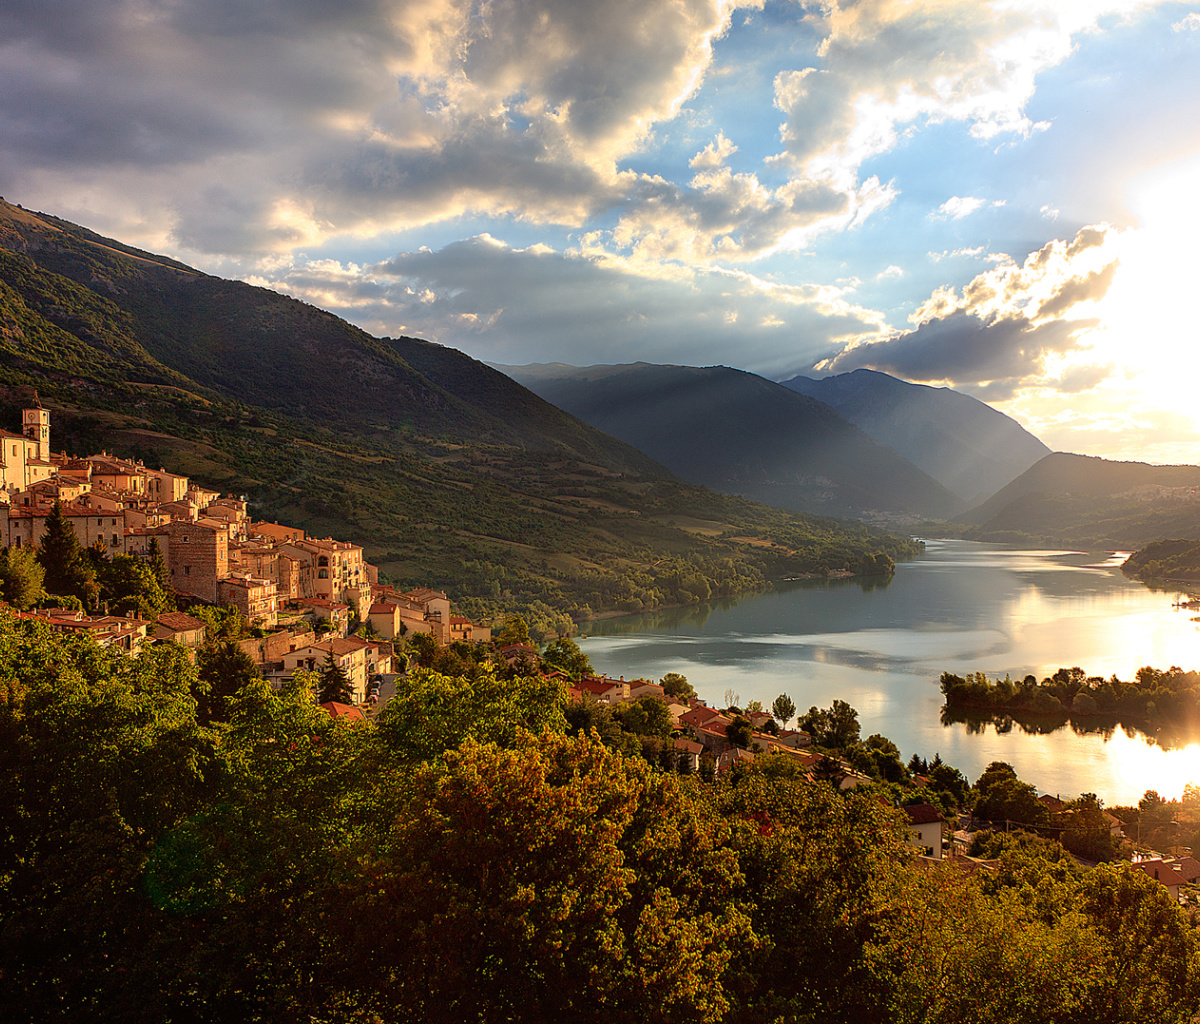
[[0, 202, 916, 629]]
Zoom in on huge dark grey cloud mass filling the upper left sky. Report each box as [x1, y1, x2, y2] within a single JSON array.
[[0, 0, 761, 253]]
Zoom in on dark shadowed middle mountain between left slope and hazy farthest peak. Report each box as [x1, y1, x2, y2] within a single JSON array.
[[502, 363, 964, 517]]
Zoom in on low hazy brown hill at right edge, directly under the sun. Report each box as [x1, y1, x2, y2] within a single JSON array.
[[958, 453, 1200, 549]]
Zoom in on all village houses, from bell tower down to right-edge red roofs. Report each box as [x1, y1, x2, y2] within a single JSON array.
[[7, 401, 1200, 897]]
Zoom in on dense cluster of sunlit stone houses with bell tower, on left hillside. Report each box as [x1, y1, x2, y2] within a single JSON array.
[[0, 402, 491, 703]]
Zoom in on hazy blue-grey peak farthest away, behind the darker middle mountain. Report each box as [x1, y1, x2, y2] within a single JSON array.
[[782, 370, 1050, 505]]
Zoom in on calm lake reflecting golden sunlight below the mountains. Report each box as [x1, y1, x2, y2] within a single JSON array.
[[580, 540, 1200, 804]]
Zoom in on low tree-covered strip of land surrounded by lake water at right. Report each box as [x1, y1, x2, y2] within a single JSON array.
[[941, 666, 1200, 743]]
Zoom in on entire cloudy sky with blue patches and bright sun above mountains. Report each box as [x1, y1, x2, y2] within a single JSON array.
[[0, 0, 1200, 463]]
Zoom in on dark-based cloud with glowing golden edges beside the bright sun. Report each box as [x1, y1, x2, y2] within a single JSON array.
[[818, 226, 1118, 399]]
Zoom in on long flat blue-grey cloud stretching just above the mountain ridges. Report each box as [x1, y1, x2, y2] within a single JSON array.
[[257, 235, 883, 373]]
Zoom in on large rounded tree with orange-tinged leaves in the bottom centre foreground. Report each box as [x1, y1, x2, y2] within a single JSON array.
[[319, 736, 751, 1024]]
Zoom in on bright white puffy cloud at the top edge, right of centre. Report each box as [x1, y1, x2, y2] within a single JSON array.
[[775, 0, 1145, 187]]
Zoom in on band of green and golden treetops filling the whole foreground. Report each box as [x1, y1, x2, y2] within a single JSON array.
[[0, 618, 1200, 1024]]
